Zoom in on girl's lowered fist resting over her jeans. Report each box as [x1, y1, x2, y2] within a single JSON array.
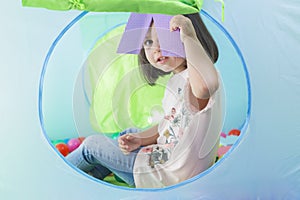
[[118, 133, 142, 155]]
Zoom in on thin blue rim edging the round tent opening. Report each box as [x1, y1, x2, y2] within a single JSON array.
[[38, 9, 252, 192]]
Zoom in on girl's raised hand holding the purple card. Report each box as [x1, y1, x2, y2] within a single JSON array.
[[170, 15, 197, 42]]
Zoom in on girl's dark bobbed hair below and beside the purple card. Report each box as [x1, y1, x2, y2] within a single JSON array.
[[138, 13, 219, 85]]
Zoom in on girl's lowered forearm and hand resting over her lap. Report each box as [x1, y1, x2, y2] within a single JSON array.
[[118, 125, 159, 154]]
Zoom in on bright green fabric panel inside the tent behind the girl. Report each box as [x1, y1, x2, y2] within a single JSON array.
[[85, 26, 170, 135]]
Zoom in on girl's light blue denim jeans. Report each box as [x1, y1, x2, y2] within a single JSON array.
[[66, 129, 139, 186]]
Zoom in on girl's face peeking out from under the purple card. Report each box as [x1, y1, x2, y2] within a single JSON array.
[[143, 23, 186, 73]]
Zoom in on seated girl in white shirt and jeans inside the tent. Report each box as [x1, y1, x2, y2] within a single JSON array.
[[67, 13, 222, 188]]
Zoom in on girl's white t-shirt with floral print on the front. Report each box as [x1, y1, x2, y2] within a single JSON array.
[[133, 70, 223, 188]]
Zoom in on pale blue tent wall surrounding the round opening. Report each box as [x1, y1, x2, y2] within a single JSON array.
[[0, 0, 300, 200]]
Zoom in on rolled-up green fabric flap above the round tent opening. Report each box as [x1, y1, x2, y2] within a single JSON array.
[[22, 0, 203, 15]]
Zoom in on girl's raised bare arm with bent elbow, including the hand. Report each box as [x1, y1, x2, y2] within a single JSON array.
[[170, 15, 219, 99]]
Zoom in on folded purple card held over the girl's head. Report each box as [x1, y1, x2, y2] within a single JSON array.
[[117, 13, 185, 58]]
